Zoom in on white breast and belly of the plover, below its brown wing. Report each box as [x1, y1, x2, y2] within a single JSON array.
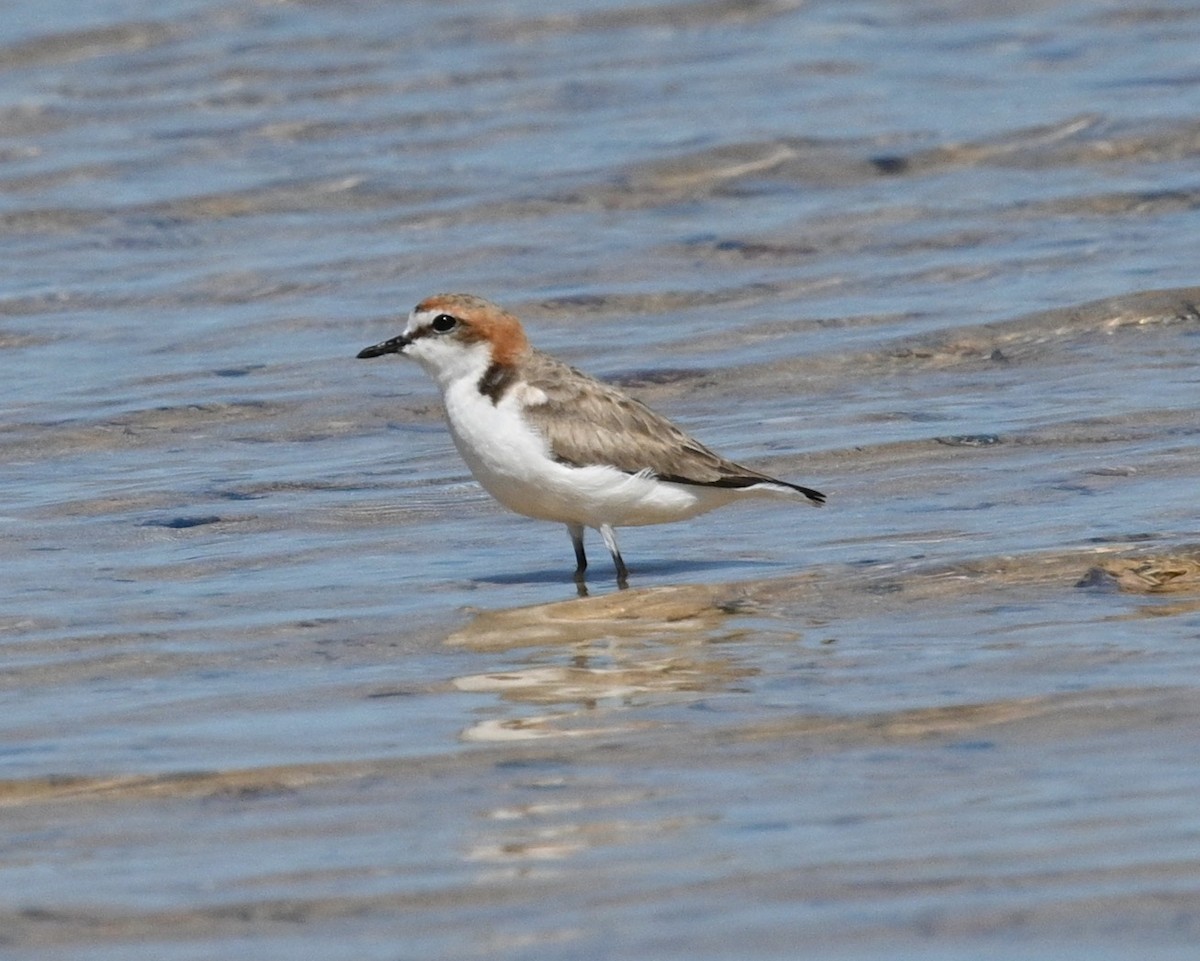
[[444, 384, 736, 527]]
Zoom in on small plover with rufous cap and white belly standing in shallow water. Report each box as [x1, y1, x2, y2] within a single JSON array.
[[359, 294, 824, 590]]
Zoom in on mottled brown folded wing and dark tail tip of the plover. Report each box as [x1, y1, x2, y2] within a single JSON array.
[[516, 350, 824, 503]]
